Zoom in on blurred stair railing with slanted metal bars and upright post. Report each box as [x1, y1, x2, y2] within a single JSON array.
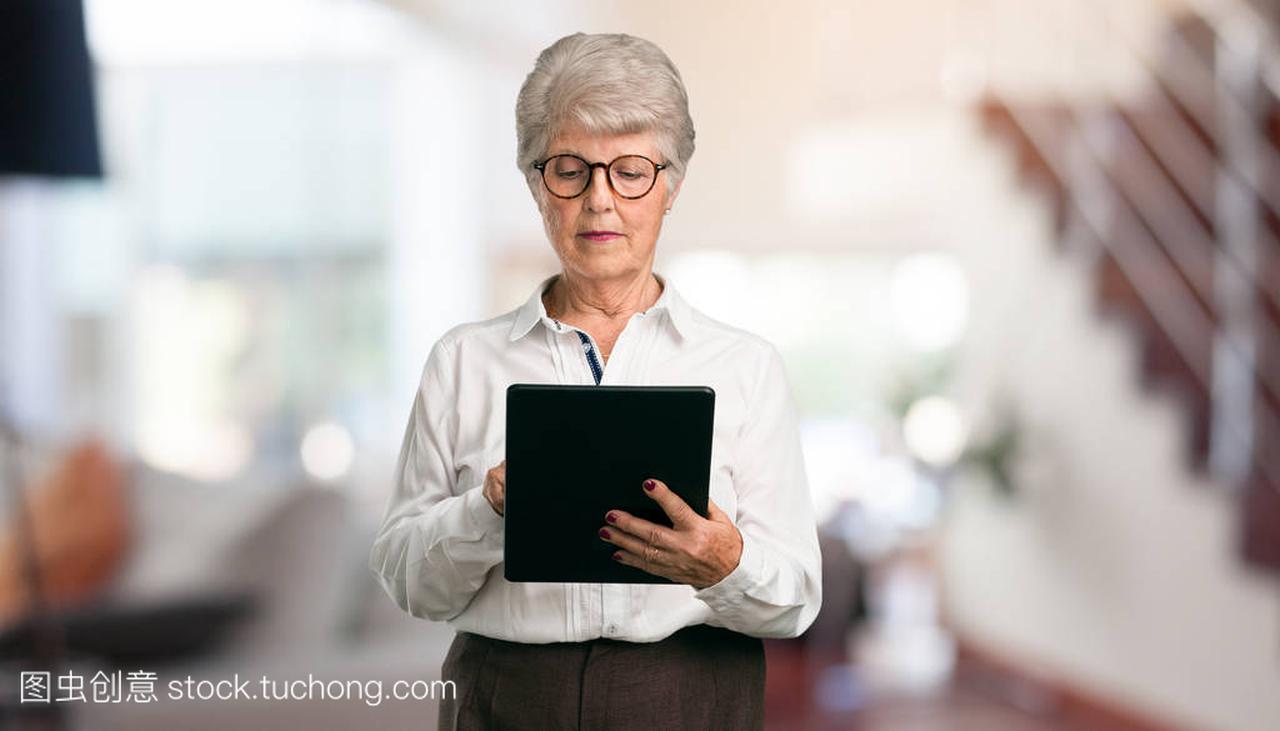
[[977, 0, 1280, 489]]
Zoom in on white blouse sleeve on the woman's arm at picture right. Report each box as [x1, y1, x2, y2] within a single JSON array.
[[695, 346, 822, 638]]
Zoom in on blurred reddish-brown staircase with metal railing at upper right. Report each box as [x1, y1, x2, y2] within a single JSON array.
[[980, 0, 1280, 572]]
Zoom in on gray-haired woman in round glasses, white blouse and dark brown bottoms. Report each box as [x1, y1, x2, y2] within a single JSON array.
[[370, 33, 820, 731]]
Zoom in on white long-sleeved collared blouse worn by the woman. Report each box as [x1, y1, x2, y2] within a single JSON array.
[[370, 277, 822, 643]]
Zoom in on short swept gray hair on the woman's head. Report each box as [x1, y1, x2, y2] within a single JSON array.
[[516, 33, 694, 196]]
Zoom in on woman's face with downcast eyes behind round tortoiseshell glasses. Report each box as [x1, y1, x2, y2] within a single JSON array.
[[538, 129, 680, 282]]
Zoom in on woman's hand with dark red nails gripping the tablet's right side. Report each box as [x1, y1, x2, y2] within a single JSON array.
[[600, 480, 742, 589]]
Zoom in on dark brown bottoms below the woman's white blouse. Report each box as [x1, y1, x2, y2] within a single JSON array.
[[440, 625, 764, 731]]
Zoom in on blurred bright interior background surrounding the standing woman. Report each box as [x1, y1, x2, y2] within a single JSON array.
[[0, 0, 1280, 731]]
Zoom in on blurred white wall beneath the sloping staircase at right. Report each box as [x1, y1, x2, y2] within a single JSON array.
[[941, 141, 1280, 731]]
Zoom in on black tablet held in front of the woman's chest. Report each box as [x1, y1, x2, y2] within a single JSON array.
[[503, 384, 716, 584]]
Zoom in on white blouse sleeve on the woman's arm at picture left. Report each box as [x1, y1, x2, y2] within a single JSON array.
[[369, 341, 503, 620]]
